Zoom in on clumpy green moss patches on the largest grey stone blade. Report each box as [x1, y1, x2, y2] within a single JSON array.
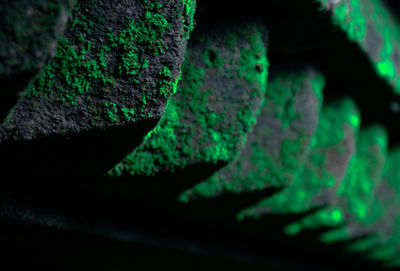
[[26, 1, 191, 123]]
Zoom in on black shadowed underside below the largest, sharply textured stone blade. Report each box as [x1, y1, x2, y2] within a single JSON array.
[[0, 120, 157, 176]]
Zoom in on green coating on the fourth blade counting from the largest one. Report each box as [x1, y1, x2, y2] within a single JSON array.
[[239, 99, 359, 221]]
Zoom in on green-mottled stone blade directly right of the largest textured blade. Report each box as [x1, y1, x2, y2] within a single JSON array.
[[110, 23, 268, 176]]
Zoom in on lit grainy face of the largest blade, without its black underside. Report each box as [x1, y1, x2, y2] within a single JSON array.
[[0, 0, 194, 142]]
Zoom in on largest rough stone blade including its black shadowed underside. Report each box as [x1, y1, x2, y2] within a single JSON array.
[[0, 0, 196, 176]]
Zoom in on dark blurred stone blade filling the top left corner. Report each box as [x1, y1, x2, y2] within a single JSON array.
[[0, 0, 75, 123]]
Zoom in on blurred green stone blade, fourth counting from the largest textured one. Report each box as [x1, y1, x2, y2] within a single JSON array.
[[238, 99, 359, 221]]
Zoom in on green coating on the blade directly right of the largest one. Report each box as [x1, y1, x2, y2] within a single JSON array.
[[109, 22, 268, 176]]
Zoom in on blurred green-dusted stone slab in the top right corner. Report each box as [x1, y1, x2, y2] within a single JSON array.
[[316, 0, 400, 93]]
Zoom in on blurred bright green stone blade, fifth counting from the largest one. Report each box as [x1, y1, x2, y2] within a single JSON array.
[[282, 123, 387, 243]]
